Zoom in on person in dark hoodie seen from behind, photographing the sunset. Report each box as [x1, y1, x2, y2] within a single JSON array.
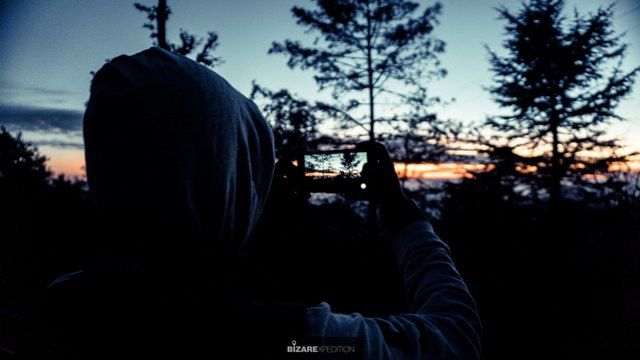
[[19, 47, 480, 359]]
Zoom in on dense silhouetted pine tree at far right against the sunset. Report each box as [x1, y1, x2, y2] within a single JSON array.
[[486, 0, 640, 206]]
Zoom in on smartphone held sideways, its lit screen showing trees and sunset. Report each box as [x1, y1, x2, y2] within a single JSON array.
[[298, 149, 369, 197]]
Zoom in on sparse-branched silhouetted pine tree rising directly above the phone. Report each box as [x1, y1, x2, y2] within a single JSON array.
[[269, 0, 446, 144]]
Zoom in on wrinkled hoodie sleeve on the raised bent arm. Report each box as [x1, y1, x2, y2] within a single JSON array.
[[307, 221, 481, 359]]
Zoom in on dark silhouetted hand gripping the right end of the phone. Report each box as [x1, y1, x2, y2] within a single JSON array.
[[356, 141, 426, 236]]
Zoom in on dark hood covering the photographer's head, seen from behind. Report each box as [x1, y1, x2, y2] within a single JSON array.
[[84, 47, 274, 249]]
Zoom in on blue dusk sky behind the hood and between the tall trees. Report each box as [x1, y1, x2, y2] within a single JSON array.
[[0, 0, 640, 174]]
